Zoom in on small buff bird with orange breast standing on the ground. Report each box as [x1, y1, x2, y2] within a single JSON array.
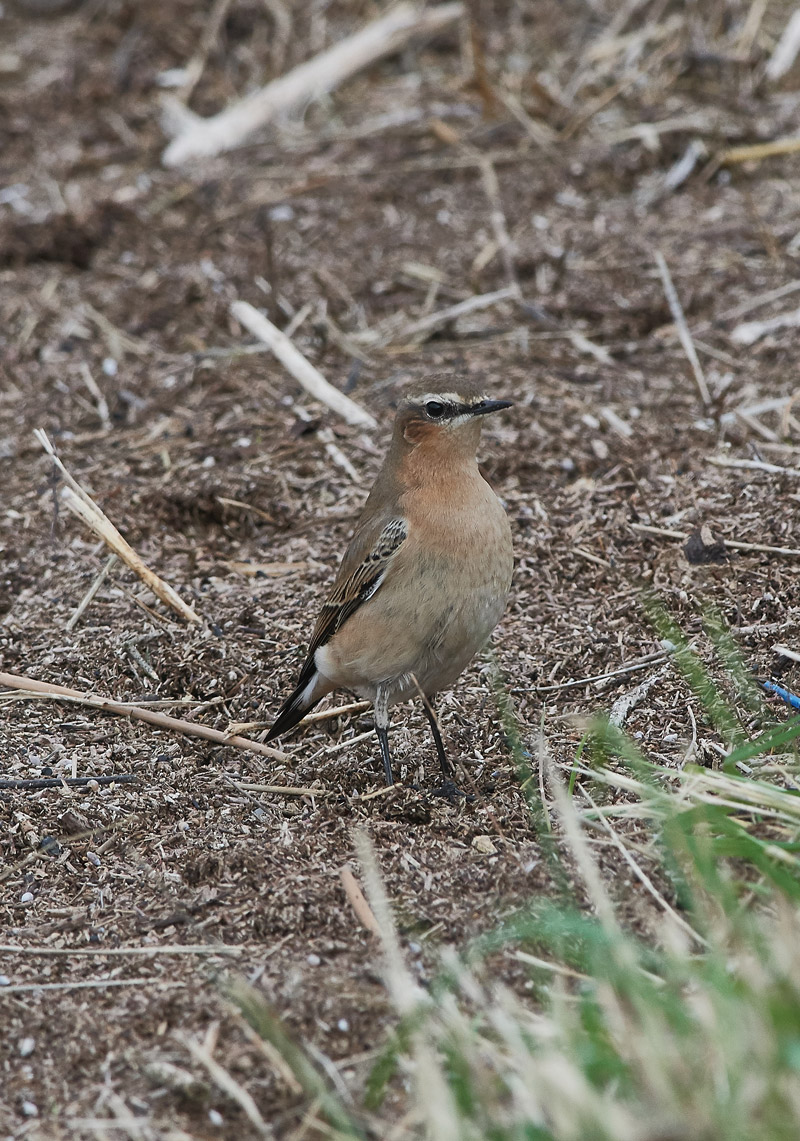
[[267, 374, 514, 785]]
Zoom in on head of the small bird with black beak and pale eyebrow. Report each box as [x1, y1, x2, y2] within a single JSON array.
[[395, 374, 512, 454]]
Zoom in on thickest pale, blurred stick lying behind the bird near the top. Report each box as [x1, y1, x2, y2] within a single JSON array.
[[162, 3, 463, 167]]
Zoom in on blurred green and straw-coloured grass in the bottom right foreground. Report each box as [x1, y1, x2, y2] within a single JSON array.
[[232, 604, 800, 1141]]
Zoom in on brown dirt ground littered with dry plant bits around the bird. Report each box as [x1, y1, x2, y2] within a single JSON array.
[[0, 0, 800, 1139]]
